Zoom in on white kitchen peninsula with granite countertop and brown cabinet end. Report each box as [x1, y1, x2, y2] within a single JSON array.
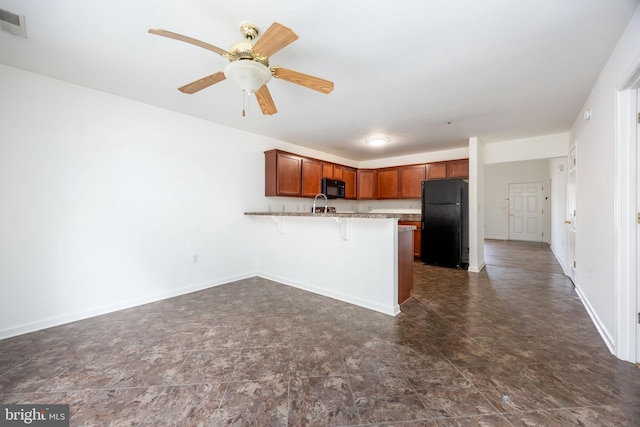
[[245, 212, 415, 315]]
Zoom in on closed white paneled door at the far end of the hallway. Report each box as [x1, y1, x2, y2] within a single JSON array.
[[509, 182, 543, 242]]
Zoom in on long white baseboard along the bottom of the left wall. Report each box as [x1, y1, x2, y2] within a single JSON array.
[[0, 273, 256, 340]]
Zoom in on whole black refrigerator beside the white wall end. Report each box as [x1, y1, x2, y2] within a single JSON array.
[[421, 179, 469, 269]]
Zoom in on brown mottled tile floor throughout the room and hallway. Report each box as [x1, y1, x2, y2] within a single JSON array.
[[0, 241, 640, 426]]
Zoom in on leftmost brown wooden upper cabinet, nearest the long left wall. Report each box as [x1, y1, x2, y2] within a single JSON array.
[[264, 150, 302, 196]]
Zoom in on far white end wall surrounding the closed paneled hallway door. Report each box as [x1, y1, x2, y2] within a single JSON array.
[[484, 159, 552, 243]]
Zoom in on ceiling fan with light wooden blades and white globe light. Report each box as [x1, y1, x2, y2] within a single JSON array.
[[149, 22, 333, 115]]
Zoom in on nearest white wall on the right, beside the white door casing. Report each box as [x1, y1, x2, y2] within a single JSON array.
[[570, 2, 640, 351]]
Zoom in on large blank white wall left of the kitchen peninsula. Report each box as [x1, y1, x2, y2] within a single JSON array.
[[0, 66, 277, 338]]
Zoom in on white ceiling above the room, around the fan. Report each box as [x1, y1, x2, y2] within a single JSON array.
[[0, 0, 639, 161]]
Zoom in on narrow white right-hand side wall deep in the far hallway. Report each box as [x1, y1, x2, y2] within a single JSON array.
[[549, 157, 569, 274]]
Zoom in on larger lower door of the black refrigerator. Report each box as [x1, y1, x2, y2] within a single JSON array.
[[421, 204, 462, 268]]
